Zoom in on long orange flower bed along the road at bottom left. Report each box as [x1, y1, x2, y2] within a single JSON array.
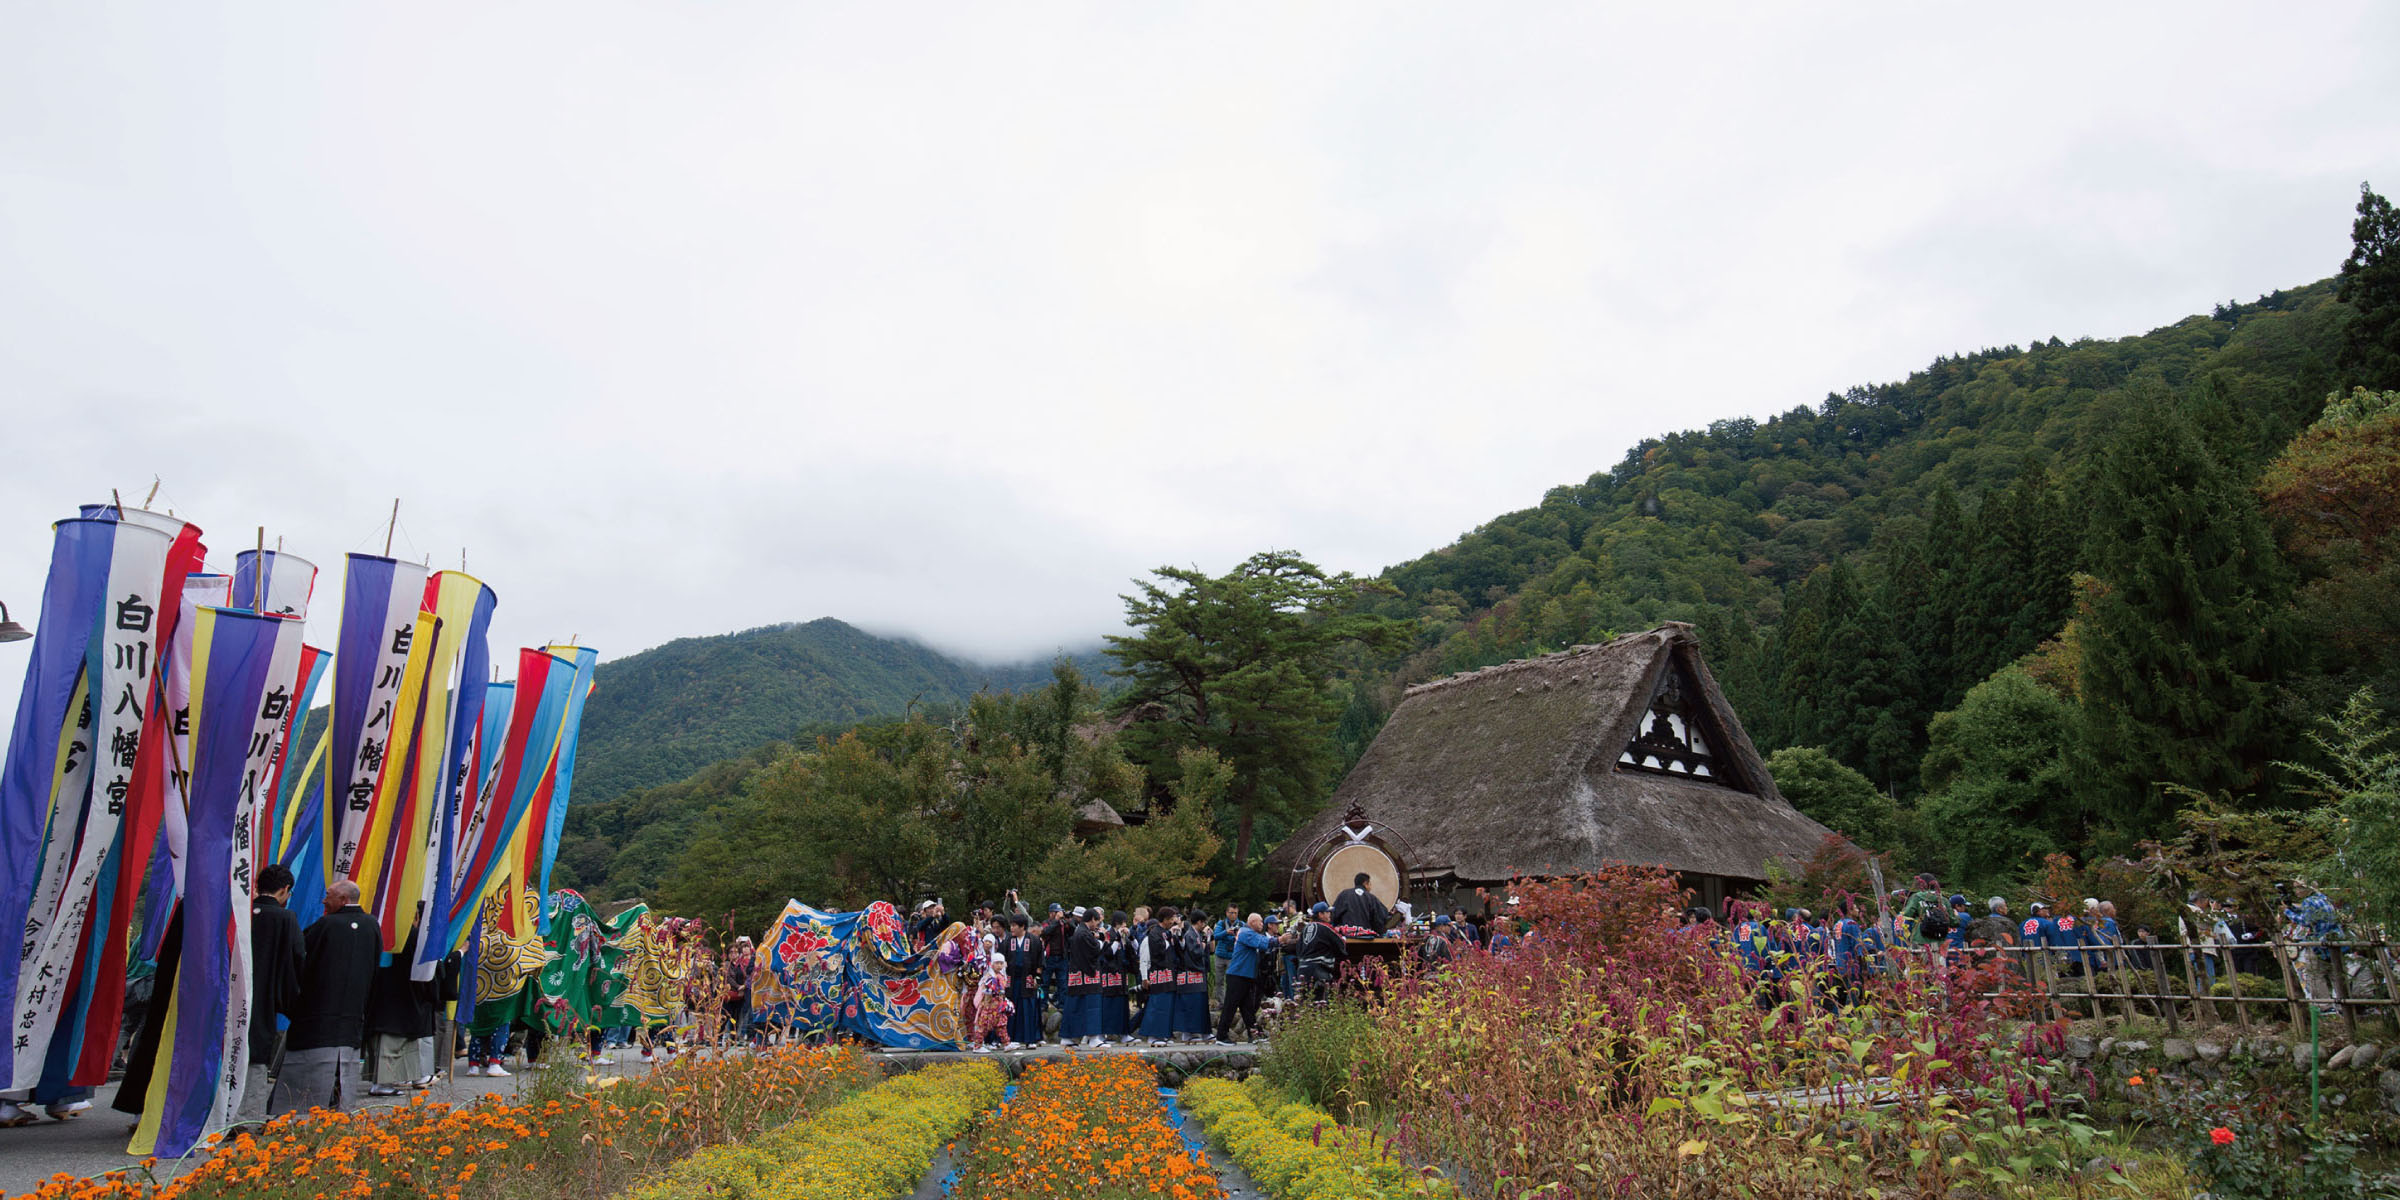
[[14, 1049, 876, 1200]]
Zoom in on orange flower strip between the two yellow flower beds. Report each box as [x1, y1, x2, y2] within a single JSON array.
[[958, 1056, 1224, 1200]]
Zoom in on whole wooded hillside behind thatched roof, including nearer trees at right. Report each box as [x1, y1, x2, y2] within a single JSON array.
[[1356, 187, 2400, 902]]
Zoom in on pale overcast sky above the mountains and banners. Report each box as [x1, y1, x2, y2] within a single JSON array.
[[0, 0, 2400, 710]]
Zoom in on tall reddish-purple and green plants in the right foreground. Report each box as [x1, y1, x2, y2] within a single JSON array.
[[1303, 866, 2090, 1198]]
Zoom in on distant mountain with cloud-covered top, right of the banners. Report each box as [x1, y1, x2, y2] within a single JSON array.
[[574, 617, 1106, 804]]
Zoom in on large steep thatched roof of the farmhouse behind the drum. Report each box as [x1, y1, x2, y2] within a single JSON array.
[[1267, 624, 1829, 883]]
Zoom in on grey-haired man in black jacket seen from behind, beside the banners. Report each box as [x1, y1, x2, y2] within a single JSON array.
[[266, 881, 384, 1116]]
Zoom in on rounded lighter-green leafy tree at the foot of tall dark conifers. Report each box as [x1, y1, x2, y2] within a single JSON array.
[[1918, 667, 2078, 890]]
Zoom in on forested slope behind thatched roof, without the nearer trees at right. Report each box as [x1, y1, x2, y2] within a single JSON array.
[[1378, 281, 2342, 768]]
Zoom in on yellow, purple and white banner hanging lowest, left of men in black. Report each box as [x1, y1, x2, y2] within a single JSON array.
[[127, 607, 285, 1157]]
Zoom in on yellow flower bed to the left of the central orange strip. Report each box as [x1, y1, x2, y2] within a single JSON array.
[[626, 1063, 1008, 1200]]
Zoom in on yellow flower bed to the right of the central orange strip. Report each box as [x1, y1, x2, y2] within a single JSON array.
[[1183, 1075, 1457, 1200]]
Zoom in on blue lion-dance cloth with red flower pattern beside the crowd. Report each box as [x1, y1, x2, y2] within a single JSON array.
[[751, 900, 965, 1049]]
